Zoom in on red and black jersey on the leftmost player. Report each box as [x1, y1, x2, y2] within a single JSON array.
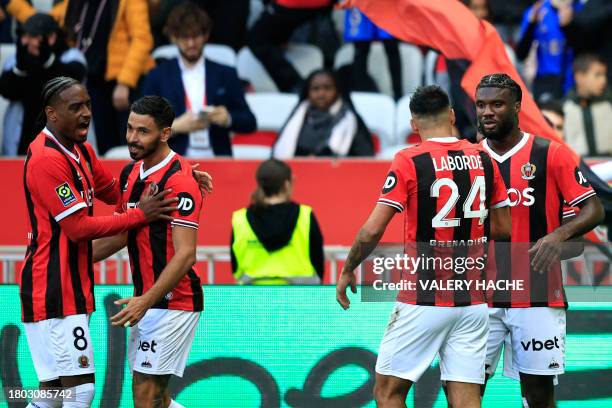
[[18, 129, 118, 322]]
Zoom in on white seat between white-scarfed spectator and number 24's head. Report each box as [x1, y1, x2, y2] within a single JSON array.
[[351, 92, 397, 152]]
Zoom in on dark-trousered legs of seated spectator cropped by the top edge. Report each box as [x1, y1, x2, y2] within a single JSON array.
[[247, 0, 335, 93]]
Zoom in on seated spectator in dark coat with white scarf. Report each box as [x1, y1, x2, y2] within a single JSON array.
[[272, 69, 374, 159]]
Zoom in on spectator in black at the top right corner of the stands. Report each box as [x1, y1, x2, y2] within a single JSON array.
[[559, 0, 612, 83]]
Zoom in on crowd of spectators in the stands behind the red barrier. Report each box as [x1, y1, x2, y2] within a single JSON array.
[[0, 0, 612, 163]]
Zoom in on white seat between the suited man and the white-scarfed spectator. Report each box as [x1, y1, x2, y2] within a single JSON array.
[[232, 92, 298, 159]]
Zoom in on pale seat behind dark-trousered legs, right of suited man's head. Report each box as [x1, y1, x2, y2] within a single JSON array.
[[237, 44, 323, 92]]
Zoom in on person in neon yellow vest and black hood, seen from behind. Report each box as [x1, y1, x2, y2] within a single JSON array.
[[230, 159, 324, 285]]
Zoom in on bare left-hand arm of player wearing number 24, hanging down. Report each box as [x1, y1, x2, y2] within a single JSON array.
[[336, 204, 397, 310]]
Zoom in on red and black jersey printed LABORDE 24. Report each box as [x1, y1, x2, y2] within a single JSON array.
[[378, 137, 507, 306]]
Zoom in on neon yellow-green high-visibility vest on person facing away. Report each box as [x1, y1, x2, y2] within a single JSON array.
[[232, 205, 320, 285]]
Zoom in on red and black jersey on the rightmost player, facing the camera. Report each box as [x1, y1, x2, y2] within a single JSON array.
[[482, 133, 595, 307]]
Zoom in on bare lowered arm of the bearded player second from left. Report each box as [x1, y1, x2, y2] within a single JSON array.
[[111, 226, 198, 326]]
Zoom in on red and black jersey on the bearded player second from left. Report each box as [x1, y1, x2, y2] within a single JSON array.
[[116, 151, 203, 311]]
